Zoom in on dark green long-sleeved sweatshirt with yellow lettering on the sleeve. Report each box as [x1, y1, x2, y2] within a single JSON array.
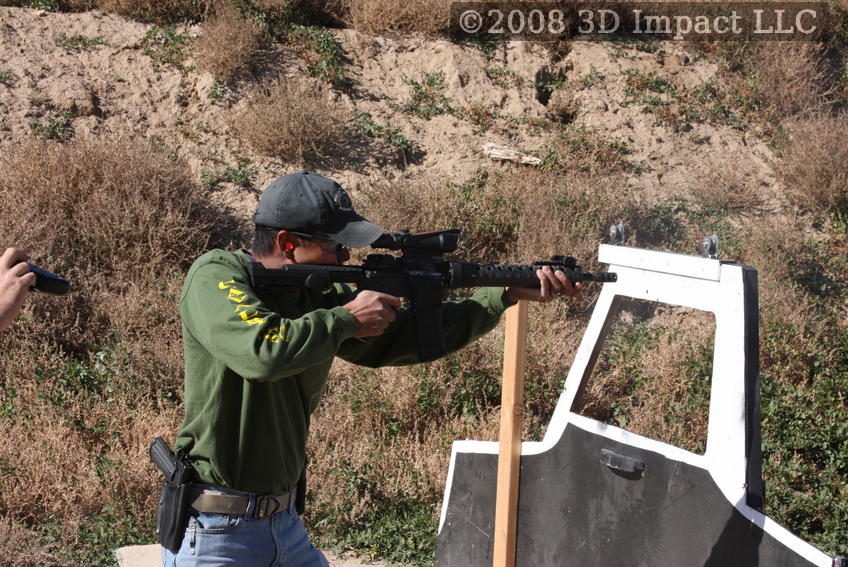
[[176, 250, 510, 494]]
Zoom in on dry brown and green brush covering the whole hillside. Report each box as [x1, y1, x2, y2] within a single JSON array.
[[0, 0, 848, 567]]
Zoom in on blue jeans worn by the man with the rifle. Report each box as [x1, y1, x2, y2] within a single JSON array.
[[162, 490, 329, 567]]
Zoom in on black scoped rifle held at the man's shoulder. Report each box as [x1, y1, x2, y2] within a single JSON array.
[[248, 230, 617, 362]]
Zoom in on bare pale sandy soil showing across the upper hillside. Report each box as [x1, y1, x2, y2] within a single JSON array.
[[0, 8, 774, 222]]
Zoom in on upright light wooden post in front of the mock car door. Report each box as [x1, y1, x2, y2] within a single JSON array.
[[493, 301, 527, 567]]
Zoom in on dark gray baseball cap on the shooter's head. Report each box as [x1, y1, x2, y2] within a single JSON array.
[[253, 170, 386, 248]]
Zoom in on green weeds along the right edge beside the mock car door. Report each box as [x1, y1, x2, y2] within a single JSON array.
[[761, 321, 848, 556]]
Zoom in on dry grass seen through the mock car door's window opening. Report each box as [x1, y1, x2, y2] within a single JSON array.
[[577, 300, 715, 452]]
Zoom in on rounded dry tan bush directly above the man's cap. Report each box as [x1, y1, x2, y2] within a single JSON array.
[[233, 79, 350, 163]]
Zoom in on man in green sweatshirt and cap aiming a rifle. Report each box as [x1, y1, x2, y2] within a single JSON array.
[[163, 171, 579, 567]]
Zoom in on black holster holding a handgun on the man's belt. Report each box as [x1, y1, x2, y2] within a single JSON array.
[[150, 437, 194, 553]]
